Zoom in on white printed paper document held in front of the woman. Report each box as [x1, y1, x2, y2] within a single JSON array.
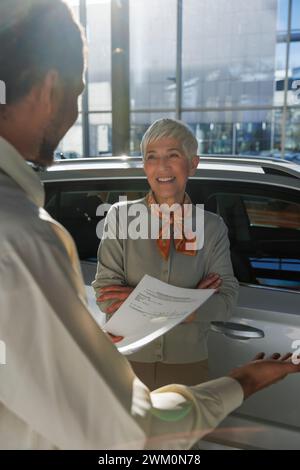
[[103, 275, 215, 354]]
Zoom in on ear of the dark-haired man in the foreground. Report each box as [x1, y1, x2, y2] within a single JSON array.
[[39, 70, 62, 116]]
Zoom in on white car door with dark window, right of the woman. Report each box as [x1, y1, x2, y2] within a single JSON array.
[[192, 178, 300, 449]]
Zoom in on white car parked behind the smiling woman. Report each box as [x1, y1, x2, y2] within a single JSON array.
[[41, 157, 300, 449]]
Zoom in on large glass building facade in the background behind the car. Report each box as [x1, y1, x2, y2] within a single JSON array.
[[57, 0, 300, 162]]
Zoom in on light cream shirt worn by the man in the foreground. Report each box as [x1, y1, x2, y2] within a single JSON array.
[[0, 138, 243, 449]]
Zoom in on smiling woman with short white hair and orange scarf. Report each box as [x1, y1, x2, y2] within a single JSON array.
[[93, 119, 238, 389]]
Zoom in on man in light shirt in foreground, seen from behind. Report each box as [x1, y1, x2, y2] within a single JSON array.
[[0, 0, 300, 449]]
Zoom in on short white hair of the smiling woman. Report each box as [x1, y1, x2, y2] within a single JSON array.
[[141, 118, 198, 158]]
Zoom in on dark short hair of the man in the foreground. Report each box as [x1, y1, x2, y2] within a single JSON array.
[[0, 0, 85, 107]]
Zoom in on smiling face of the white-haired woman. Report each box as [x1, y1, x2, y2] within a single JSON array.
[[144, 137, 199, 205]]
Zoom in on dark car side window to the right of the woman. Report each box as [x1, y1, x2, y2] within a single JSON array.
[[209, 189, 300, 291]]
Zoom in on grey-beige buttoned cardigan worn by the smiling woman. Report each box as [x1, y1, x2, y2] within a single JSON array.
[[92, 199, 238, 364]]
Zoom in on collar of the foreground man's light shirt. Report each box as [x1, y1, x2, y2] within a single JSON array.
[[0, 137, 45, 207]]
